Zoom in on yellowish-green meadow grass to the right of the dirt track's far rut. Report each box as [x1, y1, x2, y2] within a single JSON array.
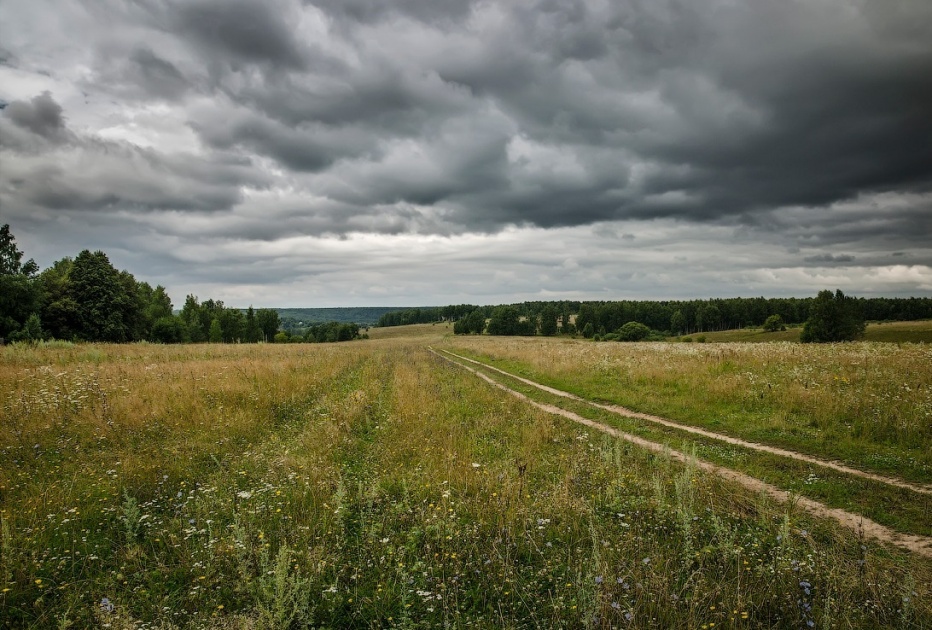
[[449, 337, 932, 483]]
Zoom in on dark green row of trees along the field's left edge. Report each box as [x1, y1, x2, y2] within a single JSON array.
[[0, 225, 359, 343]]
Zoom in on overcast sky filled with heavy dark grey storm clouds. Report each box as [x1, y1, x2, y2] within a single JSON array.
[[0, 0, 932, 307]]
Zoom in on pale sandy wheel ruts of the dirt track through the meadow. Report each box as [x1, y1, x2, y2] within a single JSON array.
[[430, 348, 932, 558]]
